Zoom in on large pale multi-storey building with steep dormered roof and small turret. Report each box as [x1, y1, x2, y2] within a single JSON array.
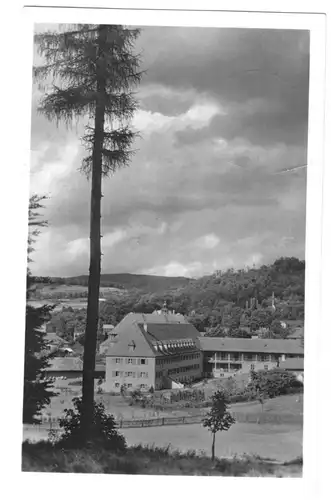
[[105, 311, 202, 392]]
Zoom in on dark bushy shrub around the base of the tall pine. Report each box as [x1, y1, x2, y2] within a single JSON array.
[[57, 398, 126, 451]]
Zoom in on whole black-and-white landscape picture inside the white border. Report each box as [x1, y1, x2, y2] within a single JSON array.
[[13, 2, 321, 478]]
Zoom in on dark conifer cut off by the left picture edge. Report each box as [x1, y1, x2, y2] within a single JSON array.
[[23, 195, 54, 423]]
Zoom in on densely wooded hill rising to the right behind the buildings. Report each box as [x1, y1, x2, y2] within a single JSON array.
[[98, 258, 305, 325]]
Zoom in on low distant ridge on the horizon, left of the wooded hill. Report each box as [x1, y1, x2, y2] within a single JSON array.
[[52, 273, 193, 293]]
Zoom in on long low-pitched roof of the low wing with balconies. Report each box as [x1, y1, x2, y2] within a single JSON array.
[[199, 337, 304, 354]]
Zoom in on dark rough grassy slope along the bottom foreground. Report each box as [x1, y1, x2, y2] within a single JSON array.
[[22, 443, 302, 477]]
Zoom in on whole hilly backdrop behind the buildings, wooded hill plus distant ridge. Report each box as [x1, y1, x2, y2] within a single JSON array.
[[43, 258, 305, 338]]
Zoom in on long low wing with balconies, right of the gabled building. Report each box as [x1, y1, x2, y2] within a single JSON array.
[[199, 337, 304, 378]]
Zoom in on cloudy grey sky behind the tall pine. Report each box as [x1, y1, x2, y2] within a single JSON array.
[[31, 27, 309, 277]]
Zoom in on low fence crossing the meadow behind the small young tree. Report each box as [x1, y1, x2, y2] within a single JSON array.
[[31, 412, 303, 429]]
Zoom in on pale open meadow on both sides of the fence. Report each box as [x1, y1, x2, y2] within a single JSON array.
[[24, 388, 303, 460]]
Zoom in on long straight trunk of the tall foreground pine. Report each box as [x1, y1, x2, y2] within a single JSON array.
[[81, 28, 107, 443]]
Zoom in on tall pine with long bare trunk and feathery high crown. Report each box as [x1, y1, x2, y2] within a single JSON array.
[[34, 25, 141, 441]]
